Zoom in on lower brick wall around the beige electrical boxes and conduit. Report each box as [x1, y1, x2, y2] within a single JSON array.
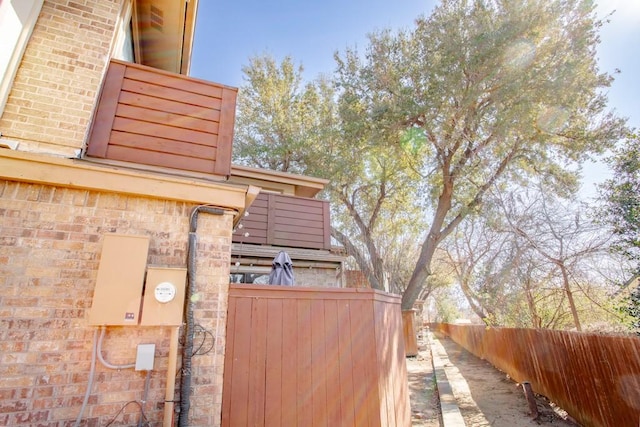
[[0, 181, 232, 426]]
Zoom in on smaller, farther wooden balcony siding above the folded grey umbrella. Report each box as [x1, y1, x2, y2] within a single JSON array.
[[233, 193, 331, 250]]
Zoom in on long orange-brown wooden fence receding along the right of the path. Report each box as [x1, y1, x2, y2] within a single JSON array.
[[431, 324, 640, 427]]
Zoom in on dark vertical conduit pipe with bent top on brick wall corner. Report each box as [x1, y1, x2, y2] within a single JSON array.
[[178, 205, 225, 427]]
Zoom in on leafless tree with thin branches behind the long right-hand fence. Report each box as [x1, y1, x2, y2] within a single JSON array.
[[442, 188, 619, 330]]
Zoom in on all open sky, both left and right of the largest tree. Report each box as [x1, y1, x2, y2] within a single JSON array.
[[191, 0, 640, 194]]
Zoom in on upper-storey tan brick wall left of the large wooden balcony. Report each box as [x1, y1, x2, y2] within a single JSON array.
[[0, 0, 122, 157]]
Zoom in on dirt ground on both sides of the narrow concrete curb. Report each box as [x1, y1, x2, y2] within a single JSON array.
[[407, 334, 579, 427]]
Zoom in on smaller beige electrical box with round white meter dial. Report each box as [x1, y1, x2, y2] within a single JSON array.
[[140, 267, 187, 326]]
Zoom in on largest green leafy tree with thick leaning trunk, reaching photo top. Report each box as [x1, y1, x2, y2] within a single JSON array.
[[337, 0, 624, 309]]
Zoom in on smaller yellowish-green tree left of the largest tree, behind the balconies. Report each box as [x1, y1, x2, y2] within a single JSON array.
[[233, 56, 421, 292]]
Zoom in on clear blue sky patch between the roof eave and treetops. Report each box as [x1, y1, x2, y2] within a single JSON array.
[[191, 0, 435, 87]]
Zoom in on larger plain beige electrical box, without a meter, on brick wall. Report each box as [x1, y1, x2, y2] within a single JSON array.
[[89, 234, 149, 326]]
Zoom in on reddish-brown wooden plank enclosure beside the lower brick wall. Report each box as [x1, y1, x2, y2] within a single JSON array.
[[222, 284, 411, 427]]
